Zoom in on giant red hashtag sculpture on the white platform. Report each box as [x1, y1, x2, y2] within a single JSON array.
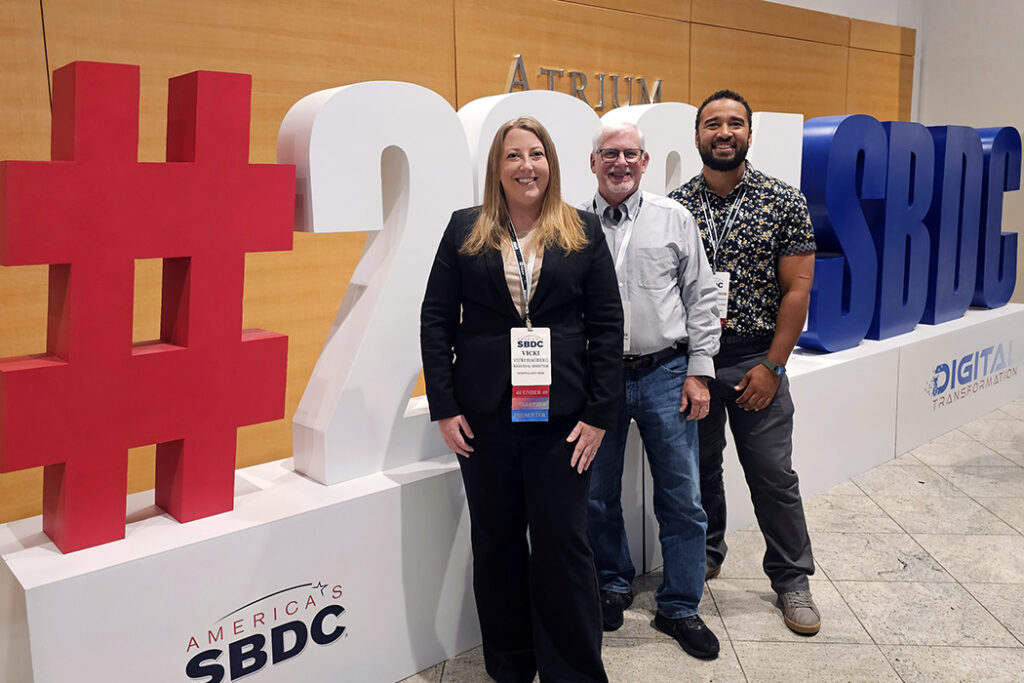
[[0, 61, 295, 552]]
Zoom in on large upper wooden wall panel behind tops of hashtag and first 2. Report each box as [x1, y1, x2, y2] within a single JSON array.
[[44, 0, 455, 162]]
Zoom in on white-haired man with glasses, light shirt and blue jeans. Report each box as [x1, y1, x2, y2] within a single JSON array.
[[583, 124, 720, 658]]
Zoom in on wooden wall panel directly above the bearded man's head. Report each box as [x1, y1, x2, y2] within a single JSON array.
[[690, 24, 847, 119]]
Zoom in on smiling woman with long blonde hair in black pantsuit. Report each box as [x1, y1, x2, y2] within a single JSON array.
[[420, 117, 623, 683]]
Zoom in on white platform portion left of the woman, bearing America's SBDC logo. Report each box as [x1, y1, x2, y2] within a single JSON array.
[[0, 456, 479, 683]]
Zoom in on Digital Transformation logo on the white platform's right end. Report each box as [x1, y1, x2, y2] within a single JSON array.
[[928, 339, 1017, 410]]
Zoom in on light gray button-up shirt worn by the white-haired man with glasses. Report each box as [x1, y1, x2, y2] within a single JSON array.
[[581, 191, 722, 377]]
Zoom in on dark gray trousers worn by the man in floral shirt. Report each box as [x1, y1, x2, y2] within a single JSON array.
[[698, 337, 814, 593]]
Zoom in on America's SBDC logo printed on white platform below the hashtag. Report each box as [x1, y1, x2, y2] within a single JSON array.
[[185, 582, 347, 683]]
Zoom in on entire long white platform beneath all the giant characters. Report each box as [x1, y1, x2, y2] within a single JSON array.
[[0, 305, 1024, 683]]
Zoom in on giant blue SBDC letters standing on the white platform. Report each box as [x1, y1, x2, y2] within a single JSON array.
[[800, 115, 1021, 351]]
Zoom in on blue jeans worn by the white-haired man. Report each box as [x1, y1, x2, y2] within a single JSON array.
[[588, 353, 708, 618]]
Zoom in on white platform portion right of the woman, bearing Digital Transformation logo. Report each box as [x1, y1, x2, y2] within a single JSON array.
[[643, 304, 1024, 571]]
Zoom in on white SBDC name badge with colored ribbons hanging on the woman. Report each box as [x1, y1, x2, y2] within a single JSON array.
[[511, 328, 551, 422]]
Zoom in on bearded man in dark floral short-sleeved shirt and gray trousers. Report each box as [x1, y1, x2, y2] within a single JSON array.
[[669, 90, 821, 635]]
